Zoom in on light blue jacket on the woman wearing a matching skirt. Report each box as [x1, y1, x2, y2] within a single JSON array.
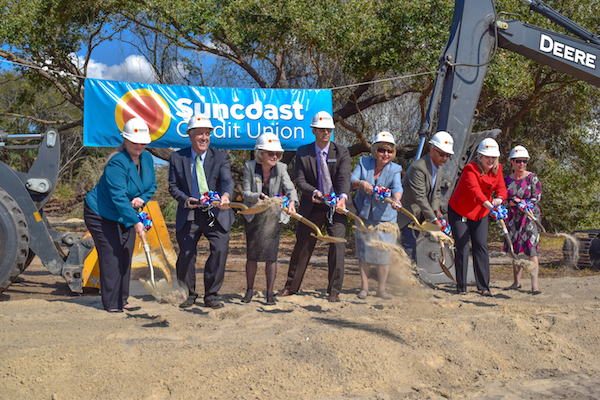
[[350, 157, 402, 224]]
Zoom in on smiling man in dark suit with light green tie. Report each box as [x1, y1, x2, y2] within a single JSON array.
[[169, 116, 235, 308]]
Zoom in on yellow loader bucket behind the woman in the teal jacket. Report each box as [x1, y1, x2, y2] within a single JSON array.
[[82, 201, 177, 289]]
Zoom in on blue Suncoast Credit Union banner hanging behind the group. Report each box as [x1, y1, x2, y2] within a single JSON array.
[[83, 79, 333, 150]]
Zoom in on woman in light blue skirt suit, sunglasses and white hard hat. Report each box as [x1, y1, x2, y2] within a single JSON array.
[[350, 132, 402, 300]]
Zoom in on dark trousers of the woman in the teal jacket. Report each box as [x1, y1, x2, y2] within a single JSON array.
[[83, 202, 135, 310]]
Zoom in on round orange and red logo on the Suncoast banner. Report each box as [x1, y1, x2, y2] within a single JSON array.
[[115, 89, 172, 141]]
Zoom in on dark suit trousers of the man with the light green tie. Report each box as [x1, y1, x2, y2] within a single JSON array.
[[176, 210, 229, 301]]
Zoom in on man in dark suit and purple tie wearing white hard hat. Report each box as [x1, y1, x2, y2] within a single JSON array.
[[278, 111, 351, 302]]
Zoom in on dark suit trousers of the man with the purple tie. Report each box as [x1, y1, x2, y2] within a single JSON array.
[[285, 205, 347, 294]]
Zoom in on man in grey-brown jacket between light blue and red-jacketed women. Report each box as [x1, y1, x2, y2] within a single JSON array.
[[398, 131, 454, 261]]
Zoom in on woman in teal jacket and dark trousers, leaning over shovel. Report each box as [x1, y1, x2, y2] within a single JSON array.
[[83, 118, 156, 312]]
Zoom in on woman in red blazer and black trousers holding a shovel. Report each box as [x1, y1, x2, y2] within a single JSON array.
[[448, 138, 506, 296]]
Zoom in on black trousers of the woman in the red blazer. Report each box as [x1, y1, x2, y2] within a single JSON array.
[[448, 207, 490, 292]]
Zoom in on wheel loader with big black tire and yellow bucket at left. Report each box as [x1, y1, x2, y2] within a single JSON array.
[[0, 130, 177, 294]]
